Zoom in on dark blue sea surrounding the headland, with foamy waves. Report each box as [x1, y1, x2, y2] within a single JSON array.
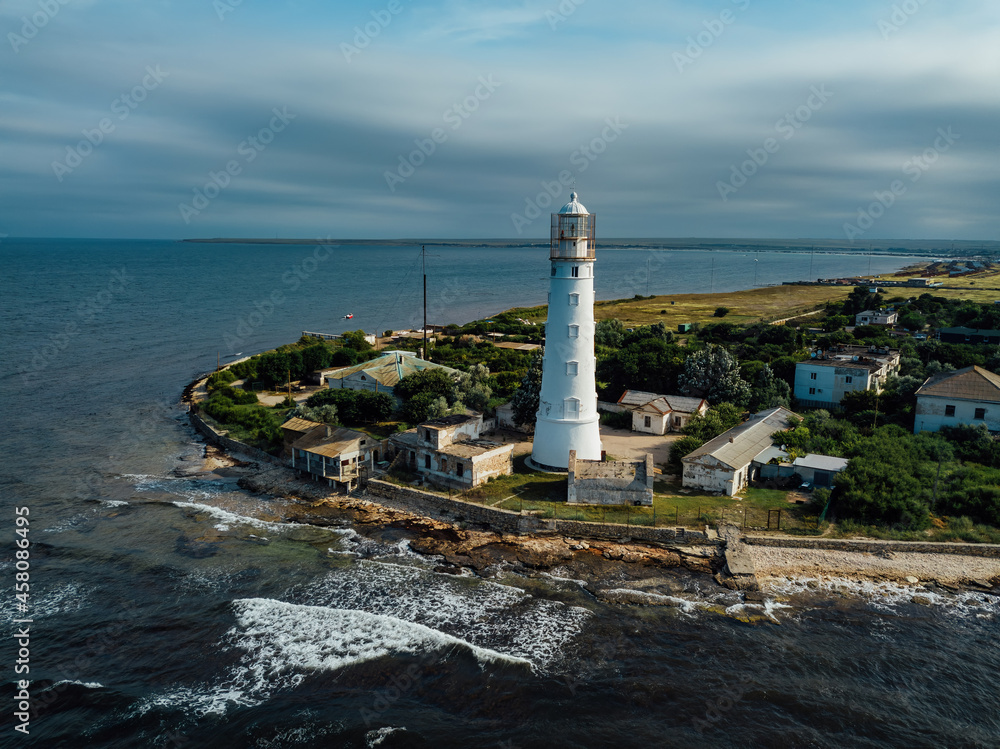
[[0, 238, 1000, 749]]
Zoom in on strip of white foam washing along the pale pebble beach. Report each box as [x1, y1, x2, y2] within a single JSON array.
[[766, 577, 1000, 617]]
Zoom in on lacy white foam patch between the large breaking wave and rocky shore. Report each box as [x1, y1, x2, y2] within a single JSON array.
[[304, 560, 591, 671]]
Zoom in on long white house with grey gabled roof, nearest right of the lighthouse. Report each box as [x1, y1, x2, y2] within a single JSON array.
[[681, 406, 798, 497]]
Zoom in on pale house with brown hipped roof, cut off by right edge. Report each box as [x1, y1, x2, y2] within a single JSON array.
[[913, 367, 1000, 434]]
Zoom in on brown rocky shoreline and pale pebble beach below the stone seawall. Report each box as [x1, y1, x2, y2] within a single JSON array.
[[188, 436, 1000, 605]]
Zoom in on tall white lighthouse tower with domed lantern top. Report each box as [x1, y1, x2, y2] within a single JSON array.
[[531, 192, 601, 470]]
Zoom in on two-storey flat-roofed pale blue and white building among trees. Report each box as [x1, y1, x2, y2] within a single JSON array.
[[794, 346, 899, 408]]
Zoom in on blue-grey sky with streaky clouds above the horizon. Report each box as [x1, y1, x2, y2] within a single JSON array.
[[0, 0, 1000, 242]]
